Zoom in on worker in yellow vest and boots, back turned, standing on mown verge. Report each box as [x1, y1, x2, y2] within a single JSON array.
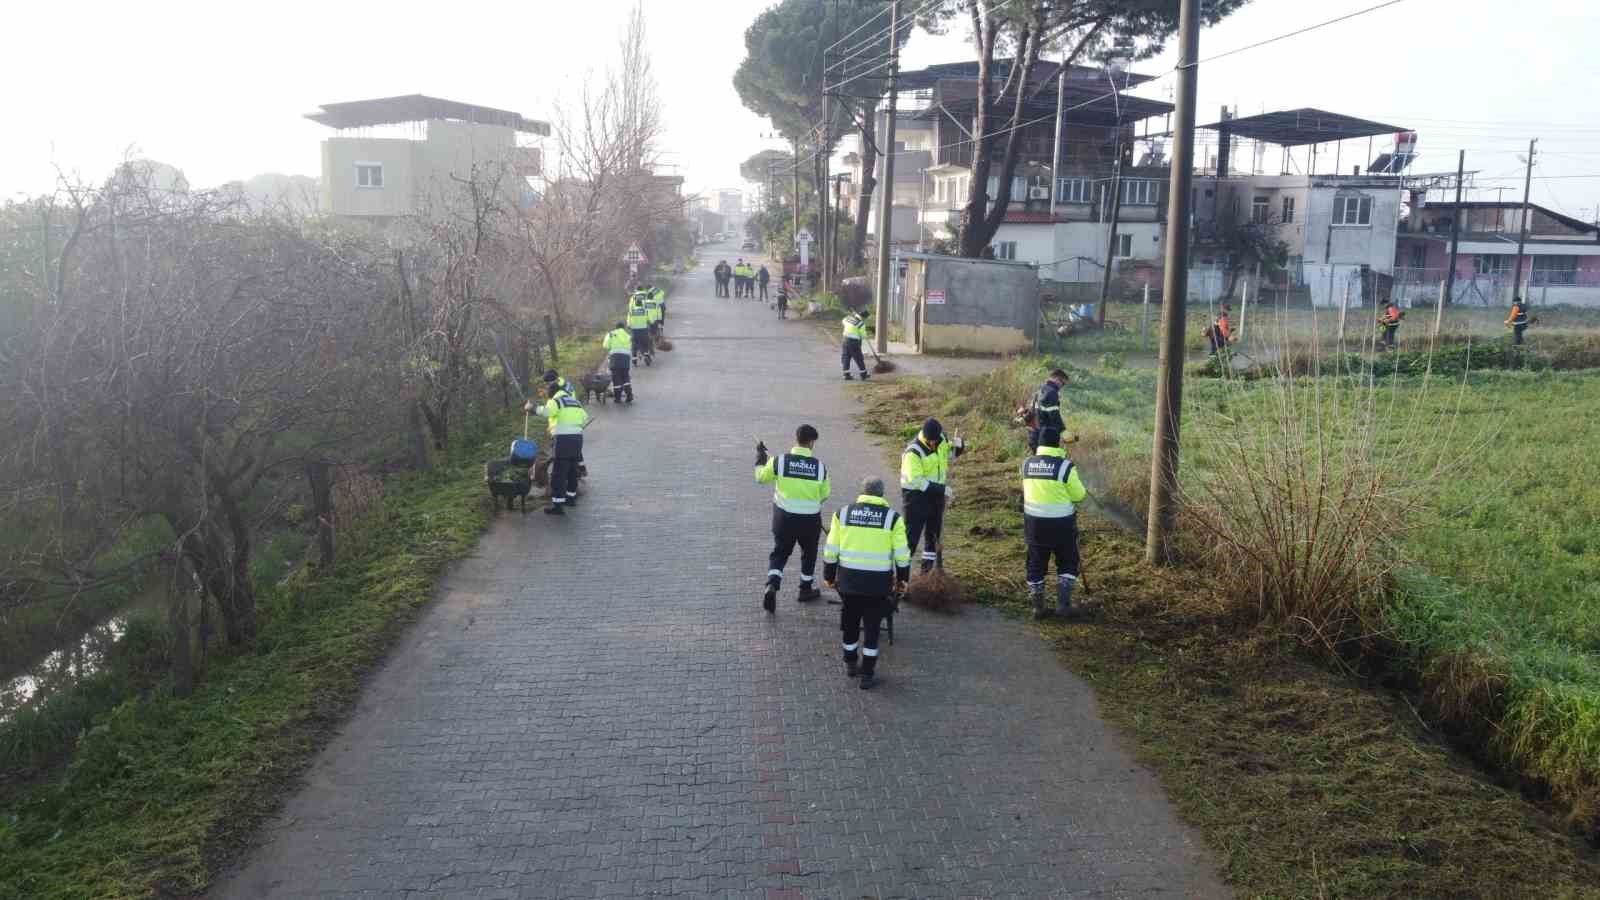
[[1022, 428, 1088, 618]]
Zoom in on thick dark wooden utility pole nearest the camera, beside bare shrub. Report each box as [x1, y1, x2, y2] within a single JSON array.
[[1144, 0, 1202, 565]]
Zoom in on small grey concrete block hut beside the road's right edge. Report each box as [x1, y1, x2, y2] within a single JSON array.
[[910, 256, 1038, 352]]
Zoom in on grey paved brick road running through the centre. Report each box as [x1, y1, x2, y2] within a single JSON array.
[[214, 259, 1226, 900]]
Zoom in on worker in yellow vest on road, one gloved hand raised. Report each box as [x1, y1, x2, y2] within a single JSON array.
[[755, 424, 832, 612]]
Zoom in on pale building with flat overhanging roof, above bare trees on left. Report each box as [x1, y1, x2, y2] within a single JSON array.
[[306, 94, 550, 224]]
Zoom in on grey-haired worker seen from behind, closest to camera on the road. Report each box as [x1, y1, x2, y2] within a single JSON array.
[[822, 479, 910, 690]]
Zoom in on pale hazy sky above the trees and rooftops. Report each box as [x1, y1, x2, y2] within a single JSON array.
[[0, 0, 1600, 219]]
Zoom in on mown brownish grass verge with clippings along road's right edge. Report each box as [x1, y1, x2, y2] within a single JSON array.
[[867, 368, 1600, 897]]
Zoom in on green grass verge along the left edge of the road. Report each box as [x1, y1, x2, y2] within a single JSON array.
[[0, 422, 502, 900]]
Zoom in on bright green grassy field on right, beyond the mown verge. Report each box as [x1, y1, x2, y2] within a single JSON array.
[[889, 359, 1600, 822]]
